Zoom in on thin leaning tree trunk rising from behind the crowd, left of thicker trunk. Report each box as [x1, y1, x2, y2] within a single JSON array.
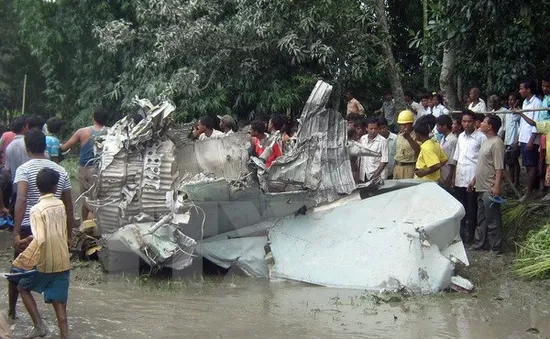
[[372, 0, 405, 112]]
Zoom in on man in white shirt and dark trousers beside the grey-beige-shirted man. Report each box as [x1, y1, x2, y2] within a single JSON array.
[[453, 110, 487, 244]]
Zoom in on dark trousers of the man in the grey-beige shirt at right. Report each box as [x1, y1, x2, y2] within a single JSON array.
[[475, 192, 502, 252]]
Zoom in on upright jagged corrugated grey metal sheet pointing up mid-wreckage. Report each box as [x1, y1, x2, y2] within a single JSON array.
[[268, 81, 357, 203]]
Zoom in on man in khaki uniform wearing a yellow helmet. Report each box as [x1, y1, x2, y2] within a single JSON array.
[[393, 110, 420, 179]]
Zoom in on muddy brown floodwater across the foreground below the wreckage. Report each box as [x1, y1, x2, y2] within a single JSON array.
[[0, 232, 550, 339]]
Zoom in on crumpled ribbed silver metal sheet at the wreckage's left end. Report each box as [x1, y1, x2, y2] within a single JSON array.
[[87, 99, 179, 235]]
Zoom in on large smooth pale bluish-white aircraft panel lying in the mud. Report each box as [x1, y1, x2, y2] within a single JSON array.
[[270, 182, 469, 294]]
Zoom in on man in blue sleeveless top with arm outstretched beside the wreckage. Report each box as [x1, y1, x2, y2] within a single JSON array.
[[61, 108, 109, 220]]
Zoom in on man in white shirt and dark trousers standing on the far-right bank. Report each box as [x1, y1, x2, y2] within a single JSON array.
[[519, 80, 542, 201]]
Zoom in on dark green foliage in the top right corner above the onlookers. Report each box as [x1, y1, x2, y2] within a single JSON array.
[[418, 0, 550, 94]]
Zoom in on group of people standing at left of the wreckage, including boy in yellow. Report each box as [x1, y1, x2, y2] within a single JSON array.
[[0, 109, 109, 338]]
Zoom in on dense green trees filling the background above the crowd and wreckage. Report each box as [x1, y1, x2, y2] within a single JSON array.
[[0, 0, 550, 126]]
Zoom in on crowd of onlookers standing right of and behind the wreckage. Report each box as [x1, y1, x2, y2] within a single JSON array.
[[347, 77, 550, 253]]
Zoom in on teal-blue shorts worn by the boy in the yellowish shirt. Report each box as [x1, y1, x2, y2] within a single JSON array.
[[19, 270, 71, 304]]
